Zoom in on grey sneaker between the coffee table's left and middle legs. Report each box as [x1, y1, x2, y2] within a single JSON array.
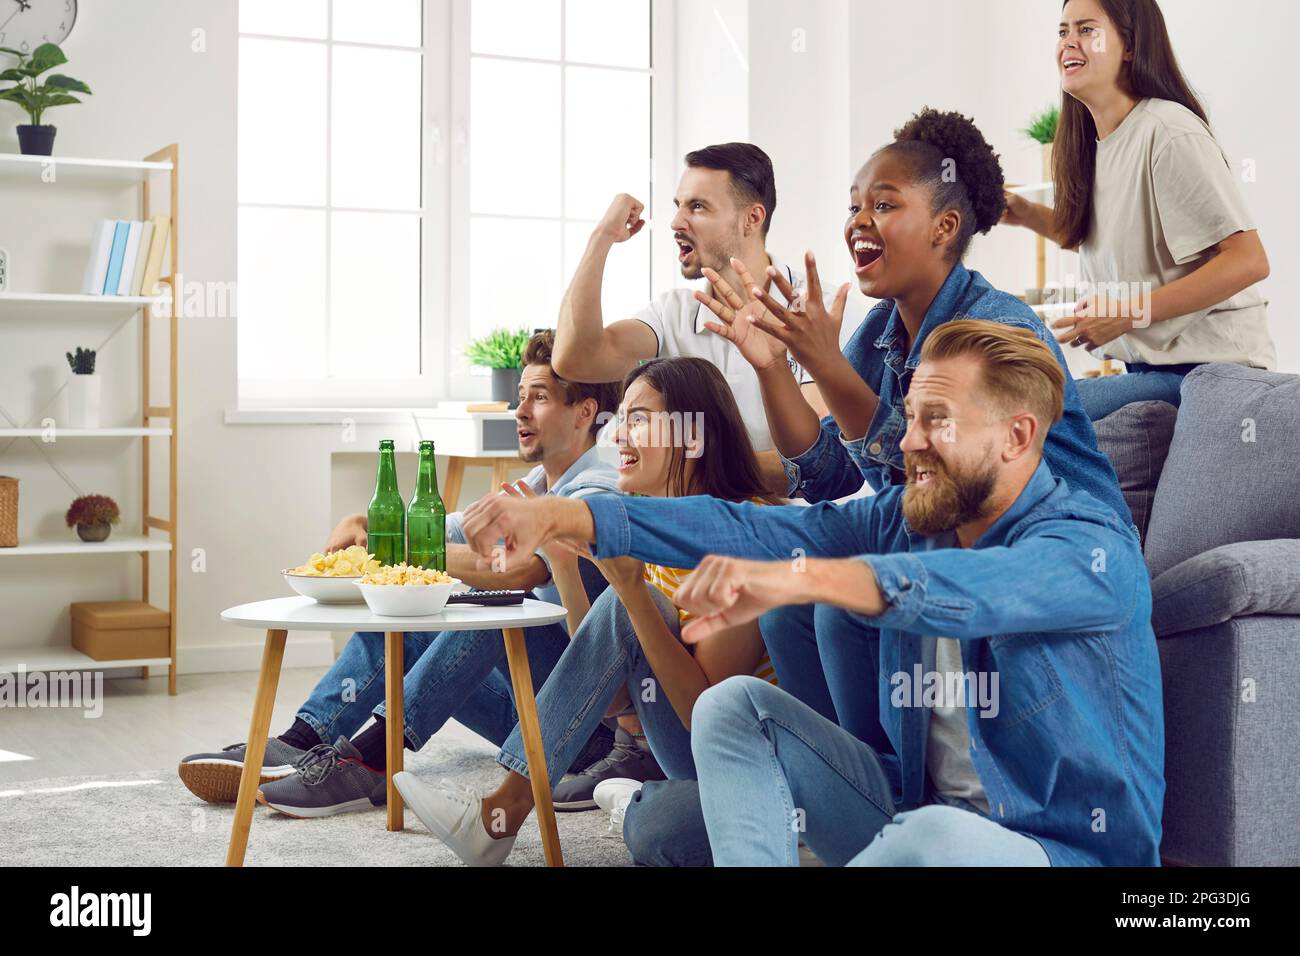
[[257, 737, 389, 817]]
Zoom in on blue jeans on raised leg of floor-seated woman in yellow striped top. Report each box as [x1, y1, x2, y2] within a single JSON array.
[[497, 588, 696, 780]]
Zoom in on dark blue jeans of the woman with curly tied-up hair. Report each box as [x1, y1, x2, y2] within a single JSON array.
[[758, 605, 893, 753]]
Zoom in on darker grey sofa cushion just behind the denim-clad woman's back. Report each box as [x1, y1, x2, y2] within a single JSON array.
[[1093, 402, 1178, 541]]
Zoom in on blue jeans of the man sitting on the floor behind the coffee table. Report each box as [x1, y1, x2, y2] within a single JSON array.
[[298, 624, 574, 754]]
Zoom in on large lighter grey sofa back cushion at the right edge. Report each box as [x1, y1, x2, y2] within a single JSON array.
[[1145, 364, 1300, 578]]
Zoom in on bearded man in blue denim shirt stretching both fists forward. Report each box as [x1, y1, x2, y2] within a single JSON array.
[[465, 321, 1165, 865]]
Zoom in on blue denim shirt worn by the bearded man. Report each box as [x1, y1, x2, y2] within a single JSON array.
[[586, 463, 1165, 866]]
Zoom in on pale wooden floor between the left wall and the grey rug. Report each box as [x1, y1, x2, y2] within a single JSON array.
[[0, 667, 477, 787]]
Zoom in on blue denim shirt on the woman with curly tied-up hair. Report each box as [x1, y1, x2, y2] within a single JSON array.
[[783, 263, 1131, 522]]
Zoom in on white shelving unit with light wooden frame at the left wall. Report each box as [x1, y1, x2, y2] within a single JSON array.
[[0, 143, 179, 695]]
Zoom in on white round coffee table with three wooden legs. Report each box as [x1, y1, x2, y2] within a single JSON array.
[[221, 596, 564, 866]]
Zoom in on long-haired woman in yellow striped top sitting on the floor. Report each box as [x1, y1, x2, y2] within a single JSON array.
[[394, 358, 776, 865]]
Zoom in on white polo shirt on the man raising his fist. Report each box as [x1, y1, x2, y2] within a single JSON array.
[[633, 255, 810, 451]]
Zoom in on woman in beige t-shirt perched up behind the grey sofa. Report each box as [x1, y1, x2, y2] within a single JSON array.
[[1004, 0, 1277, 421]]
